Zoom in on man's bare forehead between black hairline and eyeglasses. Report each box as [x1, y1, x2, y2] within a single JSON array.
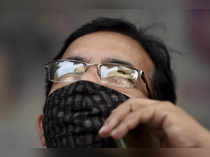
[[63, 31, 154, 72]]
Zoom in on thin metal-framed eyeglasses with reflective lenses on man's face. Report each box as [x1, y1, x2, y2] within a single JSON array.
[[46, 59, 151, 97]]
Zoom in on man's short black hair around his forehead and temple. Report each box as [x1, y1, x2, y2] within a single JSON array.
[[46, 17, 176, 103]]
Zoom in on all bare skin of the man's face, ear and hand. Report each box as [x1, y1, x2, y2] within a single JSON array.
[[38, 31, 210, 148]]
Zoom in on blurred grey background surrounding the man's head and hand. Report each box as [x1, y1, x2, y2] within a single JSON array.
[[0, 0, 210, 148]]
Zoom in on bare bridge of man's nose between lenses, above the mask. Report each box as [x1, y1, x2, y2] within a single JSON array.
[[81, 66, 100, 84]]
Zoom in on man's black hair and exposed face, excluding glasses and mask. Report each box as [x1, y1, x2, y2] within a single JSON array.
[[38, 18, 176, 147]]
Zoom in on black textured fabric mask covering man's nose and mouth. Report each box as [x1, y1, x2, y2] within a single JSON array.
[[43, 81, 129, 148]]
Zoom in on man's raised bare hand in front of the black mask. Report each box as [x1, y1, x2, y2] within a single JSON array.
[[99, 98, 210, 148]]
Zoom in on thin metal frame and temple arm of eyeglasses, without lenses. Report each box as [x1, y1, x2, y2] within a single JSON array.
[[44, 59, 152, 98]]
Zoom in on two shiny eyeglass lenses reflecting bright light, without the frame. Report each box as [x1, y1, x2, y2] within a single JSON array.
[[49, 61, 138, 88]]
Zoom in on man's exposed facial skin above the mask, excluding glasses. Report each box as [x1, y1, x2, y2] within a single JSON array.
[[49, 32, 154, 98]]
